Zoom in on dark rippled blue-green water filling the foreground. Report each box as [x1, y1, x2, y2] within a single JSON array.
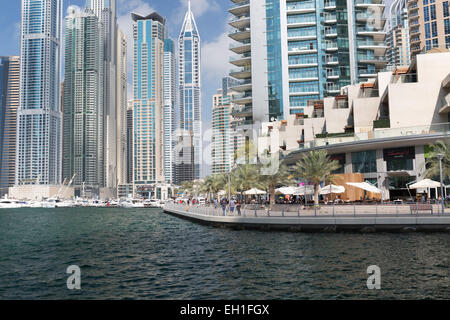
[[0, 208, 450, 299]]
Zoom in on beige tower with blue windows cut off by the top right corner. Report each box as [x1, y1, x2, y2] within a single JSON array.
[[408, 0, 450, 57]]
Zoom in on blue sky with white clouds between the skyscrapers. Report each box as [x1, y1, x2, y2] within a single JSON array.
[[0, 0, 236, 173]]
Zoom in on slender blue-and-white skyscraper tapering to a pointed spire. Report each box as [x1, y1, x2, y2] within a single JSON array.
[[176, 2, 203, 184]]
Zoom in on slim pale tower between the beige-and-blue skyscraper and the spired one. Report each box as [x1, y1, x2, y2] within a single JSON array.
[[164, 38, 178, 183]]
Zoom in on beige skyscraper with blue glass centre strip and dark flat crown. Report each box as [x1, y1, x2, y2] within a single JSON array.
[[131, 12, 165, 198]]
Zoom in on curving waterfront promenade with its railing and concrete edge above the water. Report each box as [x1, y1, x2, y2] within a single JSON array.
[[163, 204, 450, 232]]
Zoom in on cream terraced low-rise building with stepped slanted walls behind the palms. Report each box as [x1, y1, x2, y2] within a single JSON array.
[[258, 50, 450, 200]]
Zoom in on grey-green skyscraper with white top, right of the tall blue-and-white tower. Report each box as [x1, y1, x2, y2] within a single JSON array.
[[63, 7, 105, 195]]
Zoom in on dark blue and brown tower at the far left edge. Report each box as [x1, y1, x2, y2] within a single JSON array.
[[0, 56, 20, 197]]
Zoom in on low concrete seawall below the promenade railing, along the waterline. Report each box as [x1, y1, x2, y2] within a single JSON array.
[[163, 206, 450, 232]]
